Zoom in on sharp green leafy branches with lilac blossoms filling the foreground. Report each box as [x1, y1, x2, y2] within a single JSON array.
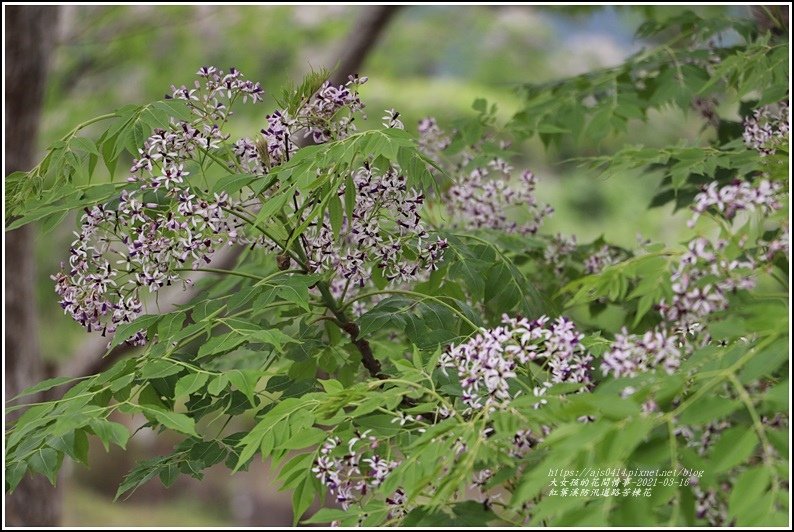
[[5, 8, 789, 526]]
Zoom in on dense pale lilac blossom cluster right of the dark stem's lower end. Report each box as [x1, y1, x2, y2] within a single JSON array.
[[439, 315, 593, 410]]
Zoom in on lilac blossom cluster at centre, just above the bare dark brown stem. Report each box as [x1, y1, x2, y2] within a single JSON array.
[[304, 163, 447, 296]]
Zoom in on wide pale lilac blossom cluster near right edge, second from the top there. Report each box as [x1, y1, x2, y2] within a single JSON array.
[[688, 179, 782, 227]]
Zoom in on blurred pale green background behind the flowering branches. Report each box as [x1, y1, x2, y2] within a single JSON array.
[[27, 5, 750, 526]]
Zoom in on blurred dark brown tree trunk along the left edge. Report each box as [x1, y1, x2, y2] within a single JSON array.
[[4, 6, 61, 526]]
